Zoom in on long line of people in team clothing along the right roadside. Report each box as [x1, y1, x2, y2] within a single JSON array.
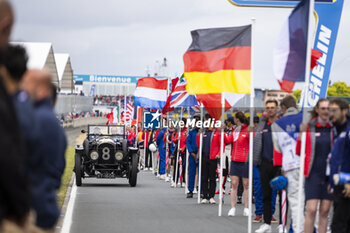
[[136, 95, 350, 233]]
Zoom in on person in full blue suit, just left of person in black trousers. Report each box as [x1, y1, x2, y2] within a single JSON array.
[[186, 115, 200, 198]]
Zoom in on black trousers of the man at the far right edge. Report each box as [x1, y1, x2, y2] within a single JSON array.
[[331, 189, 350, 233]]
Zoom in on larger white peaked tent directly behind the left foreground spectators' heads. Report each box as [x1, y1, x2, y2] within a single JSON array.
[[11, 42, 60, 87]]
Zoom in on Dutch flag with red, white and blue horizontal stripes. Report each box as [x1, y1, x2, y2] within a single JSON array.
[[134, 77, 168, 109]]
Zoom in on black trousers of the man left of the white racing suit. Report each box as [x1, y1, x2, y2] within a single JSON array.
[[259, 158, 288, 224]]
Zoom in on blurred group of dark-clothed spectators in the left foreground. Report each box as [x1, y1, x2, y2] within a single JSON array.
[[0, 0, 67, 233]]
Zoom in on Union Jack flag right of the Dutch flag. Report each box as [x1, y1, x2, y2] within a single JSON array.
[[170, 77, 198, 108]]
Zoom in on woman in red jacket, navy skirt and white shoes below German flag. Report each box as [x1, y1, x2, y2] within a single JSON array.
[[225, 112, 249, 216]]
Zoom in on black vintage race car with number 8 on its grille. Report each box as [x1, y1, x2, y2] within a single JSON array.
[[74, 125, 139, 187]]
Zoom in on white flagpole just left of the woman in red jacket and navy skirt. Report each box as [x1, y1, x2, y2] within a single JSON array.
[[218, 92, 225, 217]]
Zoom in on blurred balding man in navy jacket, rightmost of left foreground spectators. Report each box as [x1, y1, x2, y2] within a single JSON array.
[[22, 70, 67, 232]]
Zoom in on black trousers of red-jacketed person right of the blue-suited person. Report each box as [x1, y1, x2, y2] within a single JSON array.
[[201, 153, 217, 200]]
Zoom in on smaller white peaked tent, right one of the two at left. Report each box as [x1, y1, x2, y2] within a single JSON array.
[[55, 53, 74, 93]]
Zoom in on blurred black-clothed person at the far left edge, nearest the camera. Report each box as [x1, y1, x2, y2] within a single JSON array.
[[0, 31, 30, 229]]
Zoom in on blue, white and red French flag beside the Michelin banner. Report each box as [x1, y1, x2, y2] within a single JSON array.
[[273, 0, 310, 92]]
